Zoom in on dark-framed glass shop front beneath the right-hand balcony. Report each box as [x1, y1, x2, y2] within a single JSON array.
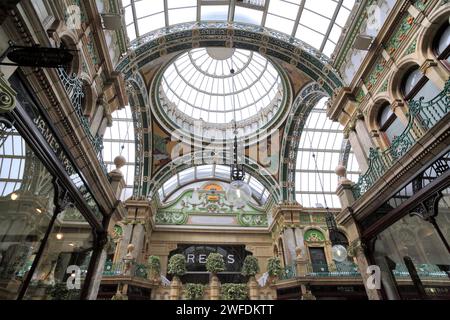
[[361, 148, 450, 300]]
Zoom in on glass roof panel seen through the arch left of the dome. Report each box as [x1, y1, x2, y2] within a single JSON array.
[[103, 106, 136, 200]]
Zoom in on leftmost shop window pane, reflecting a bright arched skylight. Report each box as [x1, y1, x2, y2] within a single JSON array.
[[0, 126, 54, 300]]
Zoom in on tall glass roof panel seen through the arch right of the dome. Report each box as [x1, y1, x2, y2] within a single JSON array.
[[295, 98, 359, 208]]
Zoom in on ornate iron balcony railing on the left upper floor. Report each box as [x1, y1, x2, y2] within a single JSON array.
[[56, 68, 107, 173]]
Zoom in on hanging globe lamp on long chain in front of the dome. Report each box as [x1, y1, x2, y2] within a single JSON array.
[[226, 57, 252, 208]]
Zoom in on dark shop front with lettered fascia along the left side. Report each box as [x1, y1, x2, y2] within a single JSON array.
[[0, 71, 107, 300]]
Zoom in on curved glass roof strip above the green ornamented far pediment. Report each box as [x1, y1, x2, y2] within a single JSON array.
[[158, 164, 270, 205]]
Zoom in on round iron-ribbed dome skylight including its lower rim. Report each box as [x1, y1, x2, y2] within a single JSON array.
[[154, 48, 289, 140]]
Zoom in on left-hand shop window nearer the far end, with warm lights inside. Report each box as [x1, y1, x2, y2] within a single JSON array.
[[25, 208, 93, 300]]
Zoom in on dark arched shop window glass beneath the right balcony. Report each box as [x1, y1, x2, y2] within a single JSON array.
[[374, 205, 450, 299]]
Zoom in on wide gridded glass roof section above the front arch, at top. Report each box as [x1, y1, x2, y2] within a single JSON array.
[[122, 0, 356, 56]]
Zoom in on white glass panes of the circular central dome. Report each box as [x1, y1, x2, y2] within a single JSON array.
[[160, 48, 283, 124]]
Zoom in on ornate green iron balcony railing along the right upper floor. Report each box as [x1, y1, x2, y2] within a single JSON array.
[[353, 80, 450, 199]]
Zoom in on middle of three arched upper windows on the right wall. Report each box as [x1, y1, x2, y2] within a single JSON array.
[[403, 67, 441, 101]]
